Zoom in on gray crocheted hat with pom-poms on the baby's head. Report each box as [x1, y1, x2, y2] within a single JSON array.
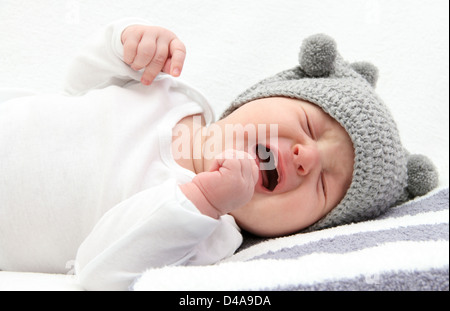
[[221, 34, 438, 231]]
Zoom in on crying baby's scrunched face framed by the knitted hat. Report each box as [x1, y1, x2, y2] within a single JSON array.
[[219, 97, 354, 236]]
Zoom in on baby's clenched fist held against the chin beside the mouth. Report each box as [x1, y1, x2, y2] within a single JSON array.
[[181, 150, 259, 218]]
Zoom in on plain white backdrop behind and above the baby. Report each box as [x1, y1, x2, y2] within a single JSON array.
[[0, 0, 449, 185]]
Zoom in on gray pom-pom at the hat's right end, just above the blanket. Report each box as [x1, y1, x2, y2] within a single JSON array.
[[407, 154, 439, 197]]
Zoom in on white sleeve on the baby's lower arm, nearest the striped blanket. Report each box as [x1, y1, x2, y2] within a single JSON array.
[[76, 179, 242, 290]]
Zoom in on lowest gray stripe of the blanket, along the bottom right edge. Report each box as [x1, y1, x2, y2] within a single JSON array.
[[264, 267, 449, 291]]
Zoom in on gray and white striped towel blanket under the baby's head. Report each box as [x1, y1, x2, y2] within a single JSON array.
[[134, 188, 449, 290]]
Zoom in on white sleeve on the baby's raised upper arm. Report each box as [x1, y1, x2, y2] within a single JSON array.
[[64, 18, 148, 95]]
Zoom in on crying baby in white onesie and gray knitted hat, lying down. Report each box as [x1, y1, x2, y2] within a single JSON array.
[[0, 19, 437, 290]]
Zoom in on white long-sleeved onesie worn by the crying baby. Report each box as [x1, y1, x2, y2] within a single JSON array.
[[0, 20, 242, 290]]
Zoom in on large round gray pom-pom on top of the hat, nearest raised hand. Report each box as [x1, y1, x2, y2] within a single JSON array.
[[298, 34, 337, 77]]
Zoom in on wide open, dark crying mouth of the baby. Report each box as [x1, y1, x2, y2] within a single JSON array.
[[256, 144, 280, 191]]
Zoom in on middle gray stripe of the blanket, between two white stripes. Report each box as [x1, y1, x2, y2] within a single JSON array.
[[248, 223, 449, 261]]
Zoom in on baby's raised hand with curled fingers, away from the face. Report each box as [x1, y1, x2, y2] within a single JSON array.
[[121, 25, 186, 85]]
